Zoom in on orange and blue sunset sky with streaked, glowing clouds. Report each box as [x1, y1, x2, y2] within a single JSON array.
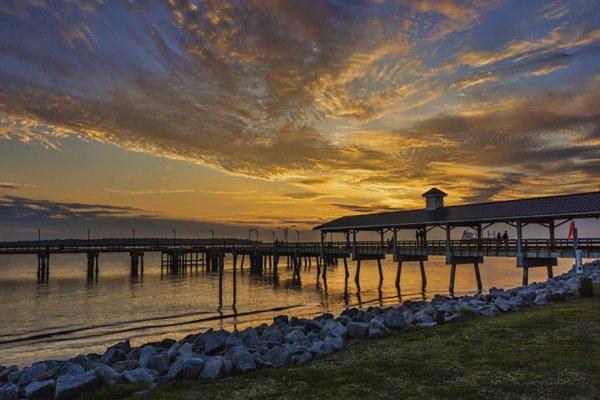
[[0, 0, 600, 240]]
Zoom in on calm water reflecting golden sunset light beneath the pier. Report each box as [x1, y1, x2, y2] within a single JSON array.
[[0, 253, 572, 366]]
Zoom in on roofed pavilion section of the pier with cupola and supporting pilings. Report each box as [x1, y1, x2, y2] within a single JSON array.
[[314, 188, 600, 292]]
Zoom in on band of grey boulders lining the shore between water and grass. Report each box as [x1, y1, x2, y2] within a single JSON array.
[[0, 260, 600, 400]]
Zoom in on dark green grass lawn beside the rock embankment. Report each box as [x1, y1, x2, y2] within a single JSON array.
[[85, 287, 600, 400]]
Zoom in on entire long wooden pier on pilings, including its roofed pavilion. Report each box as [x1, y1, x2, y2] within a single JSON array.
[[0, 189, 600, 293]]
